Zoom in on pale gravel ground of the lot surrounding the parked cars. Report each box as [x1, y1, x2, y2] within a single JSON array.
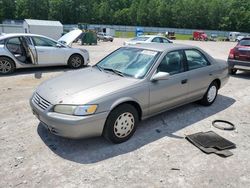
[[0, 39, 250, 188]]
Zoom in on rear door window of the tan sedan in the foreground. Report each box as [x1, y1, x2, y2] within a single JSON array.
[[185, 50, 210, 70]]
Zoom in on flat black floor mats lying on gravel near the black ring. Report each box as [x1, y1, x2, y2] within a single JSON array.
[[186, 131, 236, 157]]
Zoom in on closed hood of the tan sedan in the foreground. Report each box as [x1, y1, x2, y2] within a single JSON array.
[[36, 67, 138, 104]]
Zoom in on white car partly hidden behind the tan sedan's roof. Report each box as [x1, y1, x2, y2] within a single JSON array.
[[124, 35, 173, 46]]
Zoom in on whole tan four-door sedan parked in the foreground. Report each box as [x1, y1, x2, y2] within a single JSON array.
[[30, 44, 228, 143]]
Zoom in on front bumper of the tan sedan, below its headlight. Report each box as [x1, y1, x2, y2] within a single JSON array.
[[30, 97, 108, 139]]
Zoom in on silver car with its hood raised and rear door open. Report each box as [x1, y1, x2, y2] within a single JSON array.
[[0, 31, 89, 74]]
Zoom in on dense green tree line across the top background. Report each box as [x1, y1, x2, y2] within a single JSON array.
[[0, 0, 250, 32]]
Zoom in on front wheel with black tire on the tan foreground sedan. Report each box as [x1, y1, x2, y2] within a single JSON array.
[[103, 104, 139, 144]]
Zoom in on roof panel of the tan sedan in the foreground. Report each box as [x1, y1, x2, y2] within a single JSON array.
[[126, 43, 199, 52]]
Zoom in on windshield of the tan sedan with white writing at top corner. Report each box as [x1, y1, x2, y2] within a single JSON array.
[[97, 48, 159, 79]]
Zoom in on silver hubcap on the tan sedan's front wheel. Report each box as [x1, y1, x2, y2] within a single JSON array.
[[114, 112, 135, 138]]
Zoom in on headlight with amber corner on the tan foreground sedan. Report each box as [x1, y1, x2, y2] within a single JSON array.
[[54, 104, 97, 116]]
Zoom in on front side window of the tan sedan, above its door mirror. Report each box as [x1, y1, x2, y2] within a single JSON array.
[[157, 51, 184, 75]]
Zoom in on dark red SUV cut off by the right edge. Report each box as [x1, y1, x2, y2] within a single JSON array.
[[228, 37, 250, 74]]
